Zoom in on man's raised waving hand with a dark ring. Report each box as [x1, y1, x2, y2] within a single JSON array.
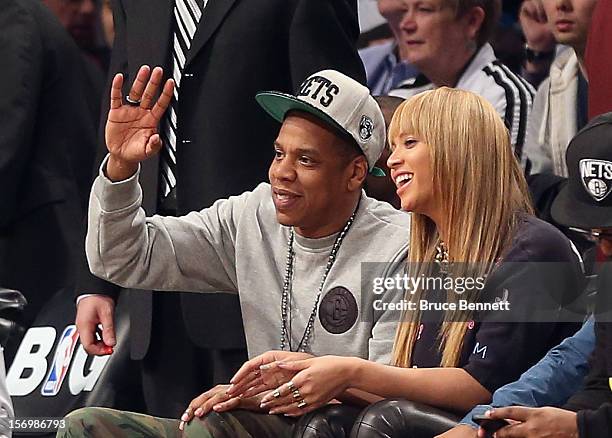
[[105, 65, 174, 181]]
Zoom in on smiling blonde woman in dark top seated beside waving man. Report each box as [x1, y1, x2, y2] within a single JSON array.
[[231, 87, 582, 437]]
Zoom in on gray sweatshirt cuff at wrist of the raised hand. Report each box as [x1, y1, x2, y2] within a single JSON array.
[[93, 155, 142, 212]]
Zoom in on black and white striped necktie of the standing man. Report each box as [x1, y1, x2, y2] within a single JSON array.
[[160, 0, 208, 202]]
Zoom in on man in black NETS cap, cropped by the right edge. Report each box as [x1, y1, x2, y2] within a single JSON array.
[[479, 113, 612, 438]]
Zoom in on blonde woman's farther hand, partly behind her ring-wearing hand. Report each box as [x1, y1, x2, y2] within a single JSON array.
[[227, 351, 313, 398]]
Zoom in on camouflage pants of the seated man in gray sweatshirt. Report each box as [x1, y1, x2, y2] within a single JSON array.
[[57, 408, 296, 438]]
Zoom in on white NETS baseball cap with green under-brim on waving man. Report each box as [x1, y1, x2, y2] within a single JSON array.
[[255, 70, 386, 176]]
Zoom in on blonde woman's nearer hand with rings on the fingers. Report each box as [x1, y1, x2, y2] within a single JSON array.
[[261, 356, 359, 416]]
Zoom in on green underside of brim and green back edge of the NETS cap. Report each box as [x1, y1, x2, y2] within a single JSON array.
[[255, 91, 385, 176]]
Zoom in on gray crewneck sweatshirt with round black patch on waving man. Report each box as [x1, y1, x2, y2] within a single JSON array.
[[86, 163, 409, 363]]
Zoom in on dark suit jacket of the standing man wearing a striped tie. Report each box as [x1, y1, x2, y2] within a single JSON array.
[[77, 0, 365, 358]]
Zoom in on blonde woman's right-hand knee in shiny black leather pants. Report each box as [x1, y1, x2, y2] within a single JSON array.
[[350, 399, 461, 438]]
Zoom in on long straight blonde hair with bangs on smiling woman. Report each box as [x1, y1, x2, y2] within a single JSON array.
[[389, 87, 533, 367]]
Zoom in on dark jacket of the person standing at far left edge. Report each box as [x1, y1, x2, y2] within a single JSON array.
[[0, 0, 98, 323]]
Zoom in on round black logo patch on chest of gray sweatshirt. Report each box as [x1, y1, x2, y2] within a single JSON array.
[[319, 286, 359, 335]]
